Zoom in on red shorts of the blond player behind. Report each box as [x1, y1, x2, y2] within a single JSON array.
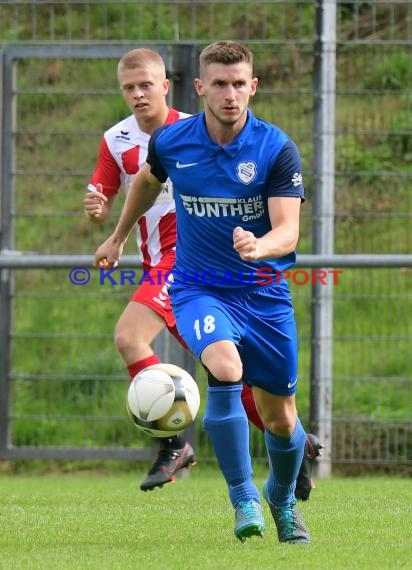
[[130, 249, 186, 348]]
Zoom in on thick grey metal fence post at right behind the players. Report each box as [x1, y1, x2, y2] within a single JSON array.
[[310, 0, 336, 478]]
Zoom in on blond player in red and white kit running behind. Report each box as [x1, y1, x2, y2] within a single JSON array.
[[84, 48, 321, 492]]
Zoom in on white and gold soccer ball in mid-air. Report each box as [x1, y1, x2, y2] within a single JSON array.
[[126, 363, 200, 437]]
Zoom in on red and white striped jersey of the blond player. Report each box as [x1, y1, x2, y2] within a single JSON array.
[[88, 109, 189, 268]]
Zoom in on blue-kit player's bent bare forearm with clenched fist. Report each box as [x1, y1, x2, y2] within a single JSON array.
[[233, 197, 301, 261]]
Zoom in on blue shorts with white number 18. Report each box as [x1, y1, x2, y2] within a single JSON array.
[[170, 283, 298, 396]]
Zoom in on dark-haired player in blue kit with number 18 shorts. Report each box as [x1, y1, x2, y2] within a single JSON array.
[[95, 41, 310, 544]]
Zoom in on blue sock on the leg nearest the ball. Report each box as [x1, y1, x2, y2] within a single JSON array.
[[203, 384, 260, 508]]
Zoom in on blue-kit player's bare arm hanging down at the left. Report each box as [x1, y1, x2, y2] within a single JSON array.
[[94, 165, 163, 267]]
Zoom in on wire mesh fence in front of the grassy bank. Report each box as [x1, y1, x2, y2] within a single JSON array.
[[0, 0, 412, 471]]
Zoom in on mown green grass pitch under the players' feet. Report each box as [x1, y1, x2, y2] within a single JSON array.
[[0, 465, 412, 570]]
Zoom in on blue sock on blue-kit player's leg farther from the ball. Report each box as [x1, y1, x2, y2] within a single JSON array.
[[265, 418, 306, 507]]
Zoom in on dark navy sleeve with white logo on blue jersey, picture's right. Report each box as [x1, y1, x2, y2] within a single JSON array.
[[267, 140, 305, 201]]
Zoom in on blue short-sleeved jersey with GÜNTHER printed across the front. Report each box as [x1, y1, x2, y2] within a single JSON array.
[[147, 110, 304, 288]]
